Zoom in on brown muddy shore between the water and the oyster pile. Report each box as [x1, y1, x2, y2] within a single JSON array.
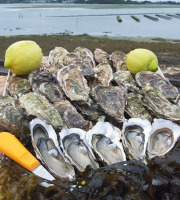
[[0, 35, 180, 68]]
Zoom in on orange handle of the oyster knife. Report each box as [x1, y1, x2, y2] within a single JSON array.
[[0, 132, 40, 171]]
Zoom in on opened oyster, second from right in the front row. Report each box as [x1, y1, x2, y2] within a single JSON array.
[[122, 118, 151, 160]]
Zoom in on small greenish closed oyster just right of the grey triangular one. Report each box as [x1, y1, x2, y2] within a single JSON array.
[[125, 92, 153, 122]]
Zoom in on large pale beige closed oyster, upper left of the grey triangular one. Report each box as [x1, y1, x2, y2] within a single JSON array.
[[57, 66, 90, 101]]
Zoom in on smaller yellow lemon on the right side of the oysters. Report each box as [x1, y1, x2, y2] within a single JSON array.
[[126, 49, 158, 75]]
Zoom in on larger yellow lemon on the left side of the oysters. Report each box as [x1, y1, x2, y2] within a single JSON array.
[[4, 40, 43, 75]]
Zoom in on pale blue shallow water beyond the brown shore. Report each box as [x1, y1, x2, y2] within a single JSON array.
[[0, 4, 180, 39]]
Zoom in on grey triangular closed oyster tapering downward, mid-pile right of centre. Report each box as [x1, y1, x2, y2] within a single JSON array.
[[93, 85, 126, 121]]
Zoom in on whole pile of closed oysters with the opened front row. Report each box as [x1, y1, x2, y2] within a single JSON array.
[[0, 47, 180, 180]]
